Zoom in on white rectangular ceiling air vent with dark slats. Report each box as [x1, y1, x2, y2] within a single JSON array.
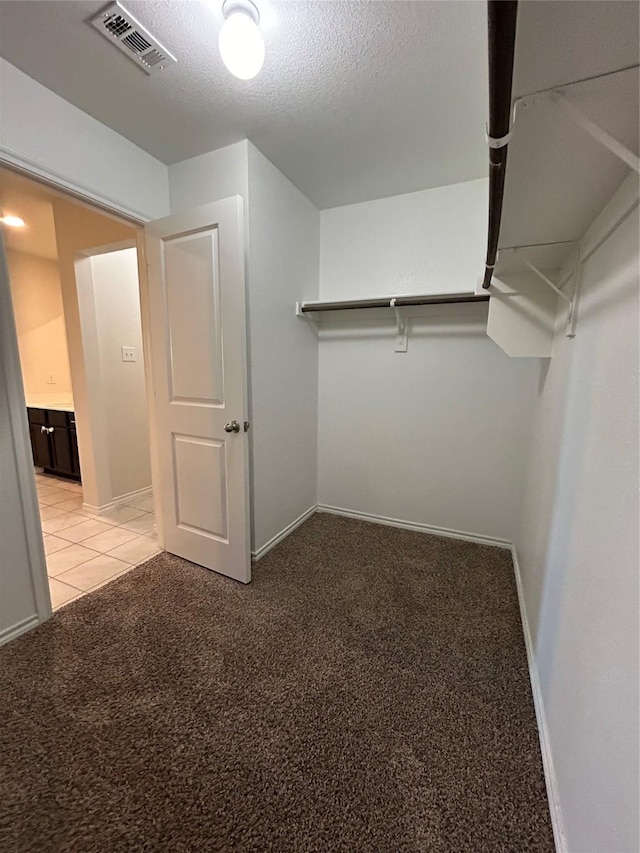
[[89, 3, 178, 74]]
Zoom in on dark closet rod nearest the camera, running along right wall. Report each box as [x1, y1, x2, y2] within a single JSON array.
[[482, 0, 518, 288]]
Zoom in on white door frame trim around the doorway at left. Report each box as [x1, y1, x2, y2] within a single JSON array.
[[0, 160, 164, 628]]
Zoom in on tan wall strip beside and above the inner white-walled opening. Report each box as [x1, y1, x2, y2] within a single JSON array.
[[53, 199, 136, 506]]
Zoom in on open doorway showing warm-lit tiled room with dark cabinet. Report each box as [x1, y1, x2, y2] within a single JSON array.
[[0, 169, 160, 610]]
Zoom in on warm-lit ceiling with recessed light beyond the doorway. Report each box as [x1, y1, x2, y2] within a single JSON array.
[[0, 169, 58, 259]]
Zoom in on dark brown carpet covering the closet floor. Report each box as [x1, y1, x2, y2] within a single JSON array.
[[0, 515, 553, 853]]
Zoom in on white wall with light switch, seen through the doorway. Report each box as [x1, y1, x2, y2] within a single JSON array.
[[83, 249, 151, 500]]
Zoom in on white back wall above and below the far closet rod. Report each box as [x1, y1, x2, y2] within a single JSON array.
[[318, 180, 537, 541]]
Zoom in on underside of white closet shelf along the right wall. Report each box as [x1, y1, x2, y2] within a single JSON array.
[[496, 0, 640, 275]]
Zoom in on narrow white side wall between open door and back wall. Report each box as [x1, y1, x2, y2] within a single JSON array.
[[248, 144, 320, 551]]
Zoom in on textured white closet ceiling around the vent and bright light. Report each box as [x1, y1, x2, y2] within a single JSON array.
[[0, 0, 490, 208]]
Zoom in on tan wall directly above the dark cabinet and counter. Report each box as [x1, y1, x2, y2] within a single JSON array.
[[7, 249, 73, 405]]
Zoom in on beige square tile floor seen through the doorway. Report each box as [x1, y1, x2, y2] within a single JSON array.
[[36, 474, 160, 610]]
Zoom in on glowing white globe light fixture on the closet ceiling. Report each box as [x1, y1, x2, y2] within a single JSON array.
[[218, 0, 264, 80]]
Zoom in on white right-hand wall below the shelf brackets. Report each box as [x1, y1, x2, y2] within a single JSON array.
[[516, 183, 640, 853]]
